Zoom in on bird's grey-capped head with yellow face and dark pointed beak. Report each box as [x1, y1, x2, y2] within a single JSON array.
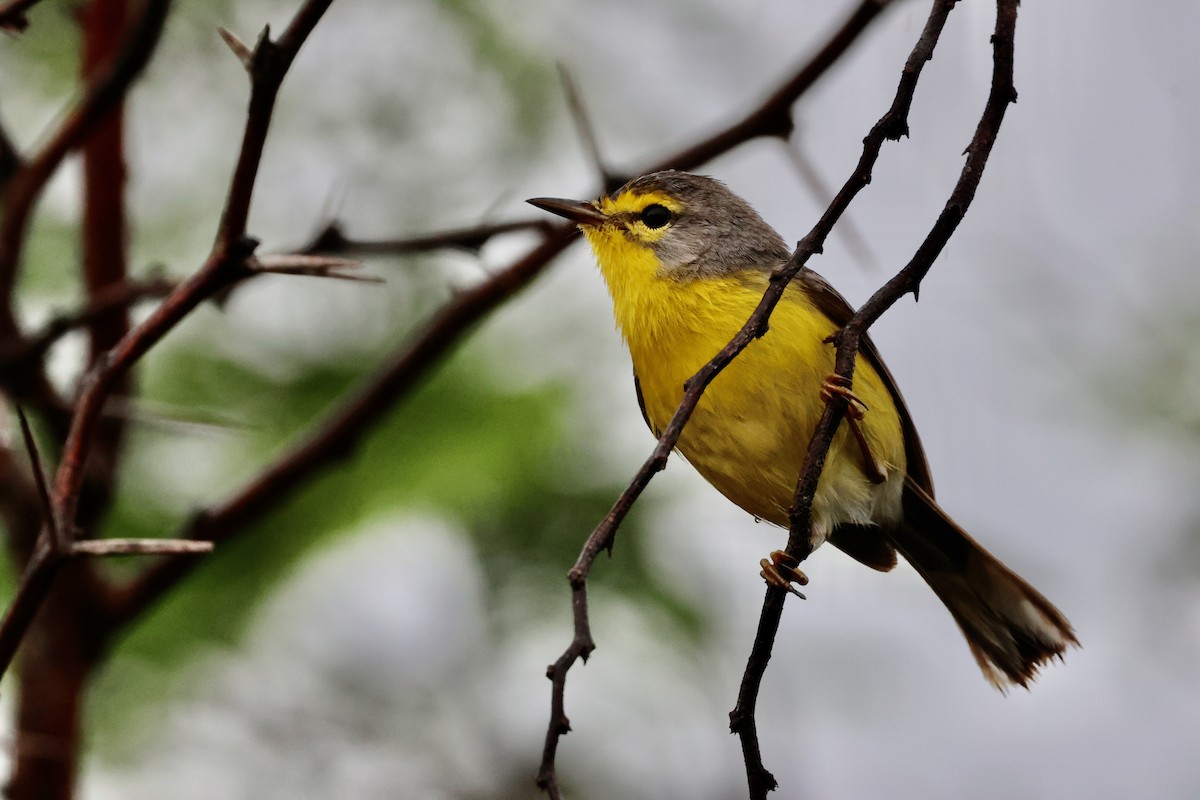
[[530, 170, 791, 279]]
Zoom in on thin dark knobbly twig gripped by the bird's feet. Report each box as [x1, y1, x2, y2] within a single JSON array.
[[730, 0, 1018, 800]]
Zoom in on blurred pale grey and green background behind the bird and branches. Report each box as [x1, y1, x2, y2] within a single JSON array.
[[0, 0, 1200, 800]]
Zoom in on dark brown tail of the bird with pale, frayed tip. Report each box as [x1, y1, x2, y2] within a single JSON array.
[[889, 481, 1079, 691]]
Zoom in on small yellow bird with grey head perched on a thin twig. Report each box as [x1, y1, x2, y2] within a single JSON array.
[[529, 172, 1078, 690]]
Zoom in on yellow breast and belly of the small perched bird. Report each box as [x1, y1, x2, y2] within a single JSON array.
[[614, 273, 905, 543]]
